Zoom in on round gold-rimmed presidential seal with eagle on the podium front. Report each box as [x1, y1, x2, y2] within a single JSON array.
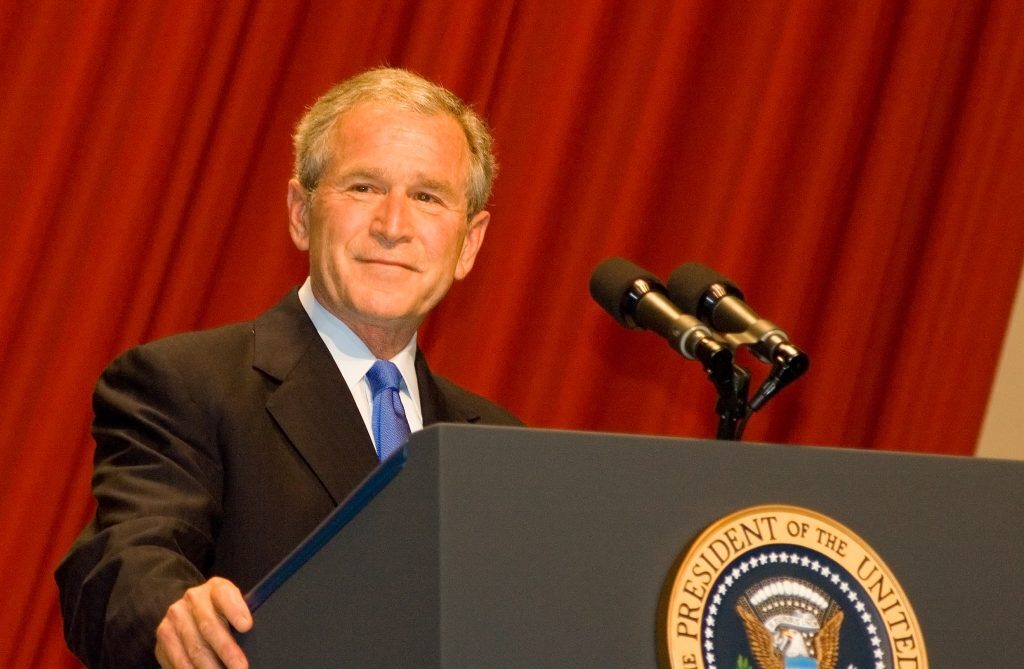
[[662, 505, 928, 669]]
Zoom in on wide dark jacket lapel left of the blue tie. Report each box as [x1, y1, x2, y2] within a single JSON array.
[[253, 291, 378, 504]]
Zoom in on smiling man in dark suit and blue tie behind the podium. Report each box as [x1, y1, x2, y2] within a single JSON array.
[[56, 68, 518, 667]]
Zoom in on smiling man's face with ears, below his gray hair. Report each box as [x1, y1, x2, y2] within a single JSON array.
[[288, 102, 489, 334]]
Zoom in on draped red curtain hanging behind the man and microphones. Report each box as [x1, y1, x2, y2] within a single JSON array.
[[0, 0, 1024, 667]]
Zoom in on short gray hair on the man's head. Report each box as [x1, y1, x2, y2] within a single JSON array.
[[293, 68, 498, 218]]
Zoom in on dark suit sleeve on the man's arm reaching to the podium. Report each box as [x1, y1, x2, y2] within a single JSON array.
[[56, 345, 222, 667]]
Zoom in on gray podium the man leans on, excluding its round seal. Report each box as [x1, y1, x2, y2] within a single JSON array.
[[241, 425, 1024, 669]]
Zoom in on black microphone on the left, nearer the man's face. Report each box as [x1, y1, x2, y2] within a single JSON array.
[[590, 258, 732, 372]]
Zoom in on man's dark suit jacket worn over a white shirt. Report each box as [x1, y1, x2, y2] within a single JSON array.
[[56, 291, 519, 667]]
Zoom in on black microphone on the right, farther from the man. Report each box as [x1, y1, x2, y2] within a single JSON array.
[[669, 262, 810, 399]]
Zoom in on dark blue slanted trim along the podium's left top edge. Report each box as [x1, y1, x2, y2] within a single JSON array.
[[246, 447, 407, 611]]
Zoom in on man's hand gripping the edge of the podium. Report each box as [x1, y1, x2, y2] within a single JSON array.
[[157, 577, 253, 669]]
